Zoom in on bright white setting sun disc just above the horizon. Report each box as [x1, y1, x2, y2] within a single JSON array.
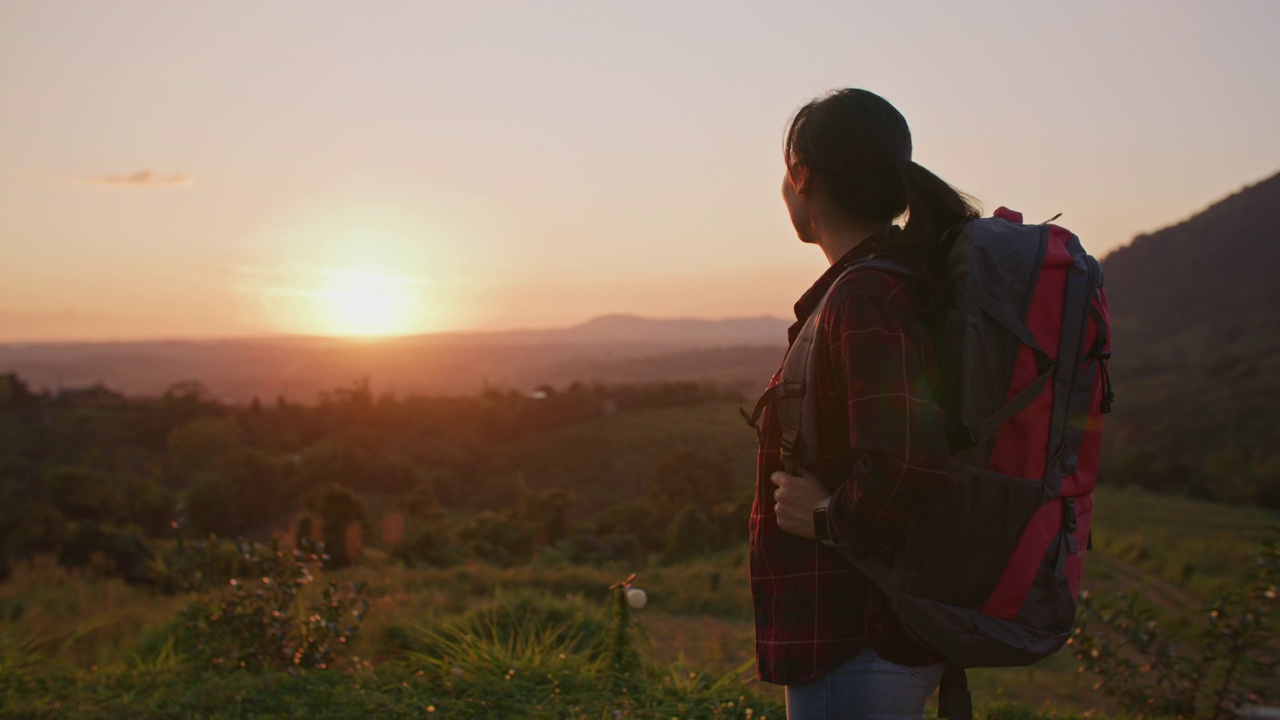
[[316, 270, 419, 337]]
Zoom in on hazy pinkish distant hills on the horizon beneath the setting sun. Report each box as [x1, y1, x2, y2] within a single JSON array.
[[0, 315, 788, 402]]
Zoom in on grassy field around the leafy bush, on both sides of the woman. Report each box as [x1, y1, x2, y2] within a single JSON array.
[[0, 488, 1277, 719]]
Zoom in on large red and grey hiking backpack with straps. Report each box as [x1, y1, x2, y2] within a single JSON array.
[[744, 208, 1114, 719]]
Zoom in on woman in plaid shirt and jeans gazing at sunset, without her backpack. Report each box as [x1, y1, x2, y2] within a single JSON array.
[[751, 90, 977, 720]]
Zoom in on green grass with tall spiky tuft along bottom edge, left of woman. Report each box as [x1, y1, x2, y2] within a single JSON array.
[[0, 579, 785, 720]]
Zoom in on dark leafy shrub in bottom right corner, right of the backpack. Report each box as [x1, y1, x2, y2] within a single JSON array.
[[1073, 530, 1280, 720]]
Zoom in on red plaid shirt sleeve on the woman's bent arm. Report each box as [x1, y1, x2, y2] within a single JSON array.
[[824, 270, 951, 555]]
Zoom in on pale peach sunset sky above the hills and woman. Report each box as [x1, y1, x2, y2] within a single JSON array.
[[0, 0, 1280, 342]]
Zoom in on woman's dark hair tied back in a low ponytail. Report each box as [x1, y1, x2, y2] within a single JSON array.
[[785, 88, 978, 300]]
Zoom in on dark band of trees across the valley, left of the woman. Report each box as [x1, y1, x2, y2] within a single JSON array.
[[0, 374, 750, 583]]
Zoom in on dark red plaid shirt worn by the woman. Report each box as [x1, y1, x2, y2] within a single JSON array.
[[750, 242, 950, 684]]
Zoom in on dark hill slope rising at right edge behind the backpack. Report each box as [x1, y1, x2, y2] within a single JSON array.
[[1102, 167, 1280, 499]]
